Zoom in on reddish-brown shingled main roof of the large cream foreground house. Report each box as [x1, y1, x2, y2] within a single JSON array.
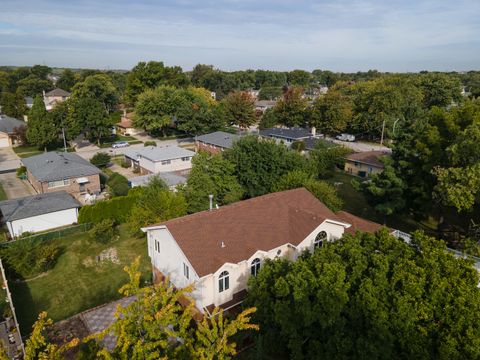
[[152, 188, 342, 277]]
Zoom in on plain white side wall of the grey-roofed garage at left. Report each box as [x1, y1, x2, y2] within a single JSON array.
[[7, 208, 78, 236]]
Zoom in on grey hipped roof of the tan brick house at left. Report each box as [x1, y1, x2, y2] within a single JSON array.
[[22, 151, 100, 182]]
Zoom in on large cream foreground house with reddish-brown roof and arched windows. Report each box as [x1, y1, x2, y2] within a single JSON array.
[[142, 188, 390, 315]]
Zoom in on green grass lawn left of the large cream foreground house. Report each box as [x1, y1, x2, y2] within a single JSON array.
[[9, 225, 151, 335]]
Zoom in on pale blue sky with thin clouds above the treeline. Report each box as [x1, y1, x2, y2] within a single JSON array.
[[0, 0, 480, 72]]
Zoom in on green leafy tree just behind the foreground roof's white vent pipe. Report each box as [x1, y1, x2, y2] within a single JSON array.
[[183, 152, 244, 213]]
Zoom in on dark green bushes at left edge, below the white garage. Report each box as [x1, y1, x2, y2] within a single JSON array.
[[0, 240, 61, 278]]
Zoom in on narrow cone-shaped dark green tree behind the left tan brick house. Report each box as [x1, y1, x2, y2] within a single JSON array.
[[27, 95, 58, 151]]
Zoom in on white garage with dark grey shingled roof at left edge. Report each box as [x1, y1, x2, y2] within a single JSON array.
[[0, 191, 80, 238]]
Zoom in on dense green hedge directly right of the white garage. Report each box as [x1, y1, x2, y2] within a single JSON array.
[[78, 193, 138, 223]]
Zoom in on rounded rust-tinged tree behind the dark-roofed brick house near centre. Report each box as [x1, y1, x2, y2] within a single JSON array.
[[221, 91, 257, 129]]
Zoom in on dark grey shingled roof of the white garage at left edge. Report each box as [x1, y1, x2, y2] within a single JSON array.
[[0, 191, 80, 221]]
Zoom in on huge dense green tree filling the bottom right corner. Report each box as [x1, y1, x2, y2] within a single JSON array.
[[244, 229, 480, 359]]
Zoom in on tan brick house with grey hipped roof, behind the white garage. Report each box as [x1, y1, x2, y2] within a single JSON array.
[[22, 151, 100, 198]]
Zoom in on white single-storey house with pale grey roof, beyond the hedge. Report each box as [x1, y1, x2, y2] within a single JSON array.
[[125, 146, 195, 174]]
